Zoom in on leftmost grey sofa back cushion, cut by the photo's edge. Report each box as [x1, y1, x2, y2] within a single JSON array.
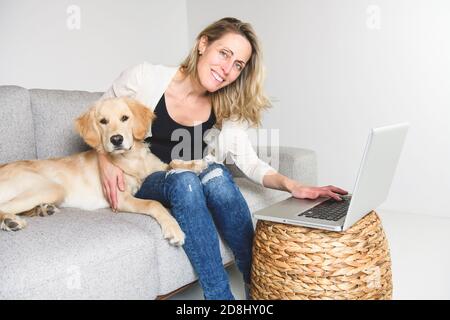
[[0, 86, 36, 163]]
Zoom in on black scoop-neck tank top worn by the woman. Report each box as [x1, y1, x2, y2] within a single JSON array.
[[145, 94, 216, 163]]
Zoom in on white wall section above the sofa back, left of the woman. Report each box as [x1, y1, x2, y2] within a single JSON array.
[[0, 0, 188, 91]]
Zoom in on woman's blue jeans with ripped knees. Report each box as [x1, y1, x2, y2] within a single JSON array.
[[135, 163, 254, 300]]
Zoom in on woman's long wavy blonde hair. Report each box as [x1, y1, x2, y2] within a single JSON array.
[[181, 18, 270, 128]]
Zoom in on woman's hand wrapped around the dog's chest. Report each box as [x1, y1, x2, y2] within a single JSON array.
[[98, 153, 125, 211]]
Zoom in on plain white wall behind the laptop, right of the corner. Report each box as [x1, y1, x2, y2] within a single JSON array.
[[187, 0, 450, 217]]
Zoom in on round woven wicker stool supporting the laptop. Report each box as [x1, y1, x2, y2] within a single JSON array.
[[251, 212, 392, 300]]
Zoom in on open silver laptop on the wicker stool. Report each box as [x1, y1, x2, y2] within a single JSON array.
[[253, 123, 409, 231]]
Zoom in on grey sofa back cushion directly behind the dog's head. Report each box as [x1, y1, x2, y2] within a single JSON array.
[[30, 89, 102, 159]]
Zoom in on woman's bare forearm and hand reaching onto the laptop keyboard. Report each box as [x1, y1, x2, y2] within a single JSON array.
[[263, 171, 348, 201]]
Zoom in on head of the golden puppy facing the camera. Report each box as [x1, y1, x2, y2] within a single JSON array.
[[75, 98, 155, 153]]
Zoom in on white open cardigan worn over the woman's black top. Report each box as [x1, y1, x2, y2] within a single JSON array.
[[100, 62, 276, 185]]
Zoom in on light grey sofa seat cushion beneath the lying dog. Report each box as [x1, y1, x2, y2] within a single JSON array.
[[0, 209, 162, 300]]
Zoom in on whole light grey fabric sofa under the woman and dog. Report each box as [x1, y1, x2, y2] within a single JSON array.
[[0, 86, 316, 300]]
